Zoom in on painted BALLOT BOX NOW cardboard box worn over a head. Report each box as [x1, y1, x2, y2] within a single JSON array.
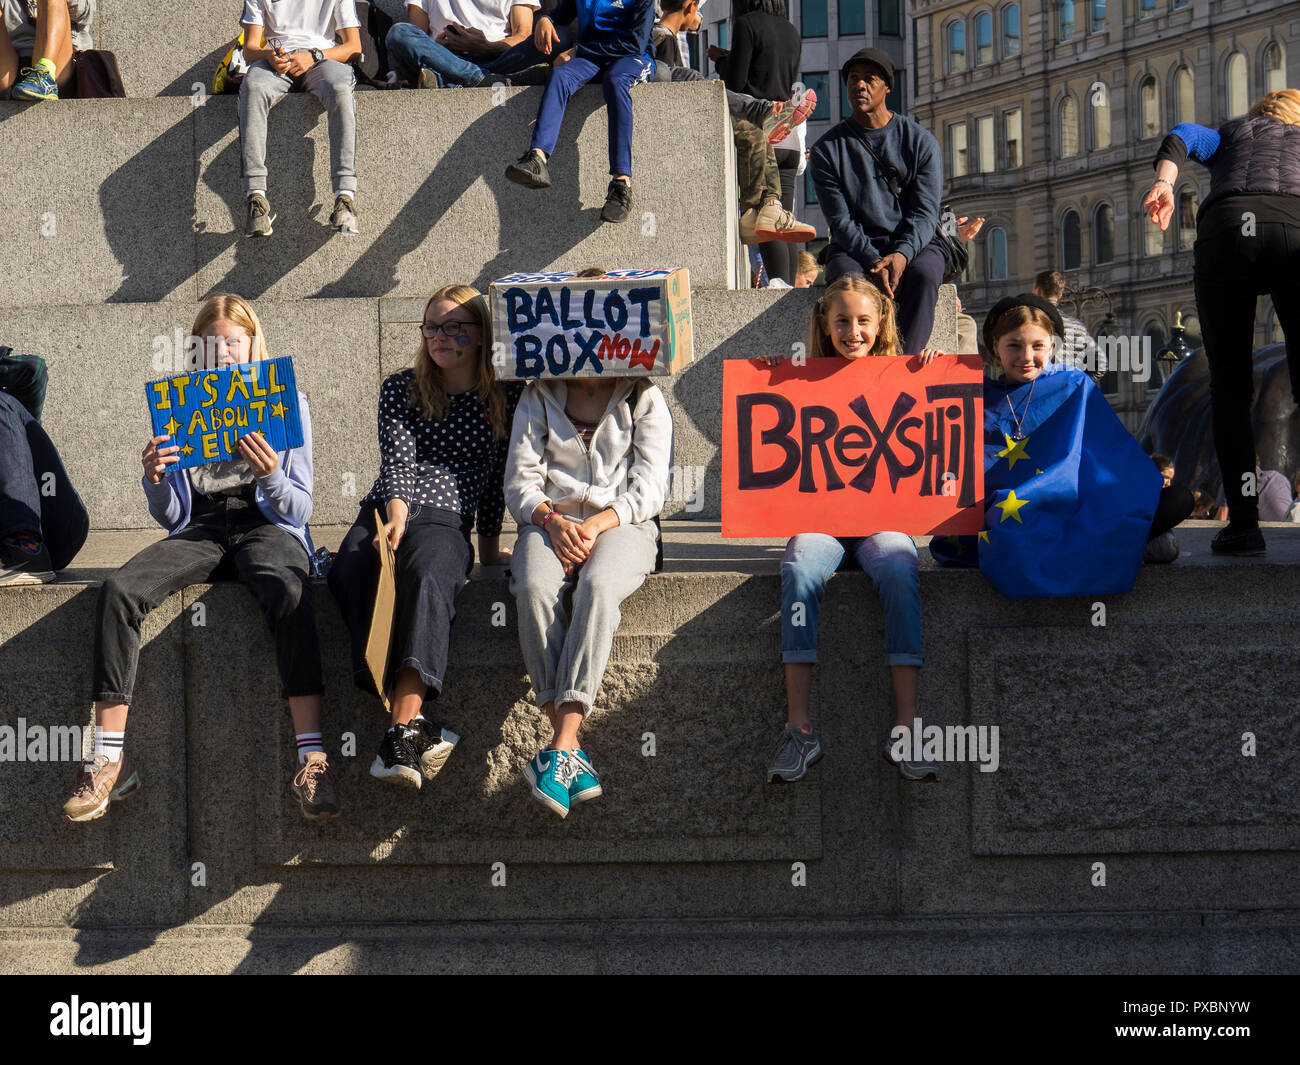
[[488, 268, 694, 381]]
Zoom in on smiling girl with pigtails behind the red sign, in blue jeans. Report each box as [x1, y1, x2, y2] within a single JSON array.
[[768, 274, 939, 782]]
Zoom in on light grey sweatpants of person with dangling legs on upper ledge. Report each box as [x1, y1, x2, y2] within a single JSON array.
[[239, 60, 356, 196]]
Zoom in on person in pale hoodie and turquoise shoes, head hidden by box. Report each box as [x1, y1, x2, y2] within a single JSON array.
[[506, 376, 672, 817]]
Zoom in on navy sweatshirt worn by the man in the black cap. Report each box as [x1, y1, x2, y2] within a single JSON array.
[[809, 113, 944, 268]]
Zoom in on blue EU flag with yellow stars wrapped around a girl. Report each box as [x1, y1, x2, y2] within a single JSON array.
[[931, 365, 1164, 598]]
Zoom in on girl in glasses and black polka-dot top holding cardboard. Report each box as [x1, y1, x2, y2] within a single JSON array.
[[329, 285, 520, 791]]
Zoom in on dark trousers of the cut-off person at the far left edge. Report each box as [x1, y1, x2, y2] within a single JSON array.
[[0, 391, 90, 570]]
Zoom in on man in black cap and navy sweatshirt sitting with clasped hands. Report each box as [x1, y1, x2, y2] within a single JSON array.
[[809, 48, 948, 354]]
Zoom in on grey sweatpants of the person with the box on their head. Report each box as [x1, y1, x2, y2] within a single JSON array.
[[510, 521, 657, 715]]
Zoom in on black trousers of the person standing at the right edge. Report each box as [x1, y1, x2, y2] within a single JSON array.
[[1195, 222, 1300, 524]]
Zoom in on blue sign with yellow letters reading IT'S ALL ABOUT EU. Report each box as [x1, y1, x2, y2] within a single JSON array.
[[144, 358, 303, 469]]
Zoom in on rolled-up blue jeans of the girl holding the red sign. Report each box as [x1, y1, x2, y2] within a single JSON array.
[[781, 532, 922, 666]]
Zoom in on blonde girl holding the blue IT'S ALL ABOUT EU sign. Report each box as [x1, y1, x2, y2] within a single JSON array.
[[64, 294, 338, 822]]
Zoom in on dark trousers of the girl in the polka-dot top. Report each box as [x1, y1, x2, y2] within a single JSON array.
[[329, 505, 475, 696]]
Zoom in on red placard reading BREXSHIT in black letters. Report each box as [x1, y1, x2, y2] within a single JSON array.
[[722, 355, 984, 536]]
